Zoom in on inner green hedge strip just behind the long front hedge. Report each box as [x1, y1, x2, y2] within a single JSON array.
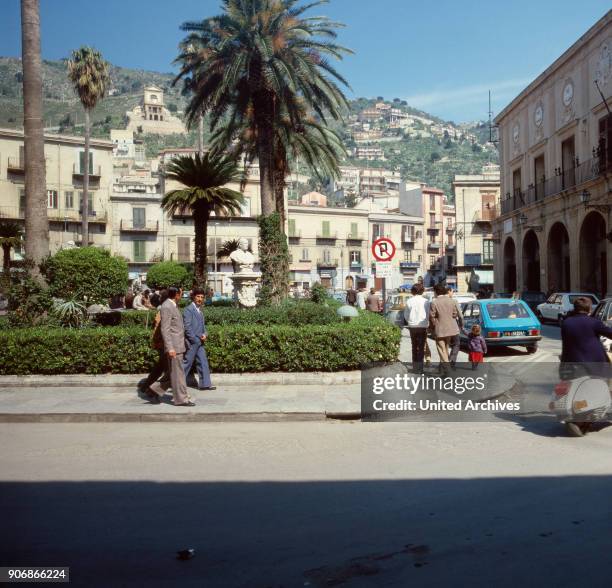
[[115, 302, 340, 327]]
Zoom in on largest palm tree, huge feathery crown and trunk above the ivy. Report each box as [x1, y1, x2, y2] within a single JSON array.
[[175, 0, 350, 223]]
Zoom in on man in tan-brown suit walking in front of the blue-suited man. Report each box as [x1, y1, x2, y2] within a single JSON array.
[[150, 287, 195, 406]]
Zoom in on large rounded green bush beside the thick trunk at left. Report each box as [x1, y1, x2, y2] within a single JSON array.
[[44, 247, 128, 304]]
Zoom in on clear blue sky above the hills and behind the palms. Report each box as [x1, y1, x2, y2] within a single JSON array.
[[0, 0, 610, 122]]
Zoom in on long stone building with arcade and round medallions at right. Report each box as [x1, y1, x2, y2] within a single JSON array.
[[493, 11, 612, 296]]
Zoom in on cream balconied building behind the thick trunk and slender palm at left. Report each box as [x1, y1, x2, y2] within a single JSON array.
[[0, 129, 113, 253]]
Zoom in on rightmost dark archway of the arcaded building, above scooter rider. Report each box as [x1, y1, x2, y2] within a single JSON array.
[[580, 211, 608, 298]]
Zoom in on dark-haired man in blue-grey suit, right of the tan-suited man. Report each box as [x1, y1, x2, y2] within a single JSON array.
[[183, 288, 215, 390]]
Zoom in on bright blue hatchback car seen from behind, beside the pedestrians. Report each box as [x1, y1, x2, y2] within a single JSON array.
[[461, 298, 542, 353]]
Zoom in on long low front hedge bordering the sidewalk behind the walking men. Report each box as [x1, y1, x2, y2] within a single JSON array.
[[0, 314, 400, 375]]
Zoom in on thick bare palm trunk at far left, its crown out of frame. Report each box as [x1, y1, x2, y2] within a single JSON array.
[[21, 0, 49, 282]]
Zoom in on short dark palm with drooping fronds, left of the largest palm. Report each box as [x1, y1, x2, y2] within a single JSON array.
[[162, 151, 244, 286]]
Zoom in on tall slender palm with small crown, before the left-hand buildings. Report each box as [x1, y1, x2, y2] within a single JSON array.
[[68, 47, 110, 247]]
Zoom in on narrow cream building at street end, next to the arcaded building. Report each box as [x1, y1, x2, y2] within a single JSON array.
[[447, 164, 500, 294]]
